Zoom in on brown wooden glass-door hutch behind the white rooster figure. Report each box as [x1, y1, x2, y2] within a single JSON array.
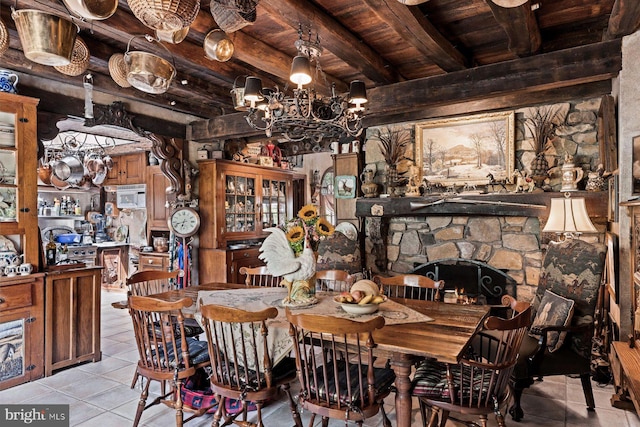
[[198, 160, 296, 283]]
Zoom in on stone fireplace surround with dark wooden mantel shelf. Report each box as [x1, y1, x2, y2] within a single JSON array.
[[356, 191, 607, 301]]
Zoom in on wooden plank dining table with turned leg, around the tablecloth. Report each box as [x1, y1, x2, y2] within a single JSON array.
[[152, 283, 491, 427]]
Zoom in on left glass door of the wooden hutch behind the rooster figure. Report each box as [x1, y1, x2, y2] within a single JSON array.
[[224, 175, 256, 233]]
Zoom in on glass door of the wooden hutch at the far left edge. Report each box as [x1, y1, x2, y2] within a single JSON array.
[[0, 112, 18, 222]]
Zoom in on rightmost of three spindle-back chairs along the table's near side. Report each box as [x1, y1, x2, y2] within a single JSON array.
[[286, 308, 395, 427]]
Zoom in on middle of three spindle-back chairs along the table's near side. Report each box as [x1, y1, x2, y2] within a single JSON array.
[[200, 301, 302, 427]]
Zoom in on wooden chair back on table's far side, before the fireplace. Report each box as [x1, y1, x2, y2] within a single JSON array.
[[373, 274, 444, 301]]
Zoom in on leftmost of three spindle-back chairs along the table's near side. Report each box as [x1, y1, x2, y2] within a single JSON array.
[[127, 295, 211, 427]]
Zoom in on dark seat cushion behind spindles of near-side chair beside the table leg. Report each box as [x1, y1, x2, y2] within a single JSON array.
[[309, 360, 396, 406]]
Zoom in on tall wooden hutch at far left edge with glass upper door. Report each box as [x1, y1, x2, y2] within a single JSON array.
[[0, 92, 45, 389]]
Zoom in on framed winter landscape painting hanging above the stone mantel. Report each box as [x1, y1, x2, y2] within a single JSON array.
[[415, 111, 515, 186]]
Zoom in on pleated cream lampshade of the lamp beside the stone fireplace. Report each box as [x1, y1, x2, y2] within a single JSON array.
[[542, 197, 598, 233]]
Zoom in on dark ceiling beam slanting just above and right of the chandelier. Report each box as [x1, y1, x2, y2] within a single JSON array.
[[258, 0, 399, 84]]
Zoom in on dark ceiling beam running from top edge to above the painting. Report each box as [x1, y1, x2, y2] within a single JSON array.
[[365, 0, 467, 72]]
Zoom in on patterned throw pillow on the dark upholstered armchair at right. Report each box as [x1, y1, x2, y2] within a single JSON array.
[[529, 290, 575, 353]]
